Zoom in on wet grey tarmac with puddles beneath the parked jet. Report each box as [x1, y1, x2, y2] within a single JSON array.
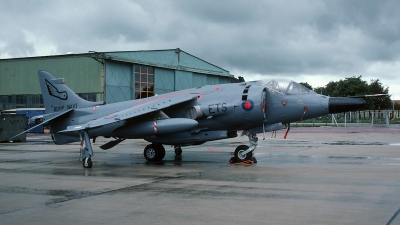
[[0, 127, 400, 225]]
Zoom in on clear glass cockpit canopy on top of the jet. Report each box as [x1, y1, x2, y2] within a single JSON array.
[[257, 78, 315, 95]]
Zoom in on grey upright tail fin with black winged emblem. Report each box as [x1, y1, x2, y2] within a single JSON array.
[[38, 70, 104, 113]]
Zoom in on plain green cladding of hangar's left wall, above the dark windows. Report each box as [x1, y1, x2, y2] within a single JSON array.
[[0, 56, 104, 95]]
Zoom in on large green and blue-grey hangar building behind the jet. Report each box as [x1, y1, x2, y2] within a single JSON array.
[[0, 48, 238, 111]]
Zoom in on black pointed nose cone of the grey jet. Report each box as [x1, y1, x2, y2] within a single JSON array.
[[329, 97, 367, 113]]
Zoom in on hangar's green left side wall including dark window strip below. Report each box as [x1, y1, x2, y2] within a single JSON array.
[[0, 55, 104, 110]]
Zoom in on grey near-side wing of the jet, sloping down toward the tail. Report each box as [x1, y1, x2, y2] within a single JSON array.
[[58, 95, 196, 133]]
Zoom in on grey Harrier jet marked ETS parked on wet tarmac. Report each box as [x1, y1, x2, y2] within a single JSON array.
[[9, 71, 366, 168]]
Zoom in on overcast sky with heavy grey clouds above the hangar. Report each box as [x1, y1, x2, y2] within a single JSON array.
[[0, 0, 400, 99]]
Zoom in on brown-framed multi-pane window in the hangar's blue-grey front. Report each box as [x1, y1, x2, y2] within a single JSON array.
[[135, 64, 154, 99]]
